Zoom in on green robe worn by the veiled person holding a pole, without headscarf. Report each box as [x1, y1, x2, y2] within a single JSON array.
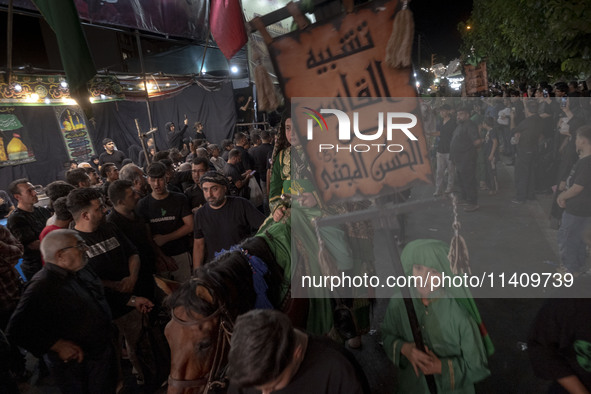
[[382, 291, 490, 394]]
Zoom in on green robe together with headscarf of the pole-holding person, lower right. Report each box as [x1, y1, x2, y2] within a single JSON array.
[[382, 240, 494, 393]]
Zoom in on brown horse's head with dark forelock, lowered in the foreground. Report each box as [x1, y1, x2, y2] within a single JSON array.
[[164, 251, 262, 394]]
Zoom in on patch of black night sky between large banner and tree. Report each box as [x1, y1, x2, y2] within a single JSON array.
[[410, 0, 472, 65]]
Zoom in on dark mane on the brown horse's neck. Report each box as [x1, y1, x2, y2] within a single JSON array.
[[166, 237, 283, 321]]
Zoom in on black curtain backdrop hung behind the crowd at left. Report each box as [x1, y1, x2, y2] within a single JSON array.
[[0, 83, 236, 190]]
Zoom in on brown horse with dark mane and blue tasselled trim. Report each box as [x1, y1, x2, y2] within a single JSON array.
[[159, 237, 306, 394]]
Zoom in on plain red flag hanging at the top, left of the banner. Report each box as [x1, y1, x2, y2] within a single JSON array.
[[209, 0, 248, 60]]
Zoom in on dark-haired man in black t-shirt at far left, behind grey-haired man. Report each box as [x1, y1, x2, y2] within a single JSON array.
[[7, 178, 51, 280]]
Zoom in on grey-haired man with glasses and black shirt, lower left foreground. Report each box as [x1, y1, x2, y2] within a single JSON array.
[[7, 229, 118, 394]]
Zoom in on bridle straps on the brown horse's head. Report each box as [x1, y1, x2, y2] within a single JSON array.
[[168, 278, 233, 394]]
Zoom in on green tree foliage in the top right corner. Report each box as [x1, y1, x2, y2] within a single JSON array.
[[458, 0, 591, 81]]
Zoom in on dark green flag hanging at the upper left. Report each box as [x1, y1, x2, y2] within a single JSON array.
[[33, 0, 96, 96]]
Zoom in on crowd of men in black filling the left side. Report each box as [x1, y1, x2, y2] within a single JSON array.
[[0, 121, 274, 393]]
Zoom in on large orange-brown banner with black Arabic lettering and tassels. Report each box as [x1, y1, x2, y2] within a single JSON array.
[[269, 1, 431, 202]]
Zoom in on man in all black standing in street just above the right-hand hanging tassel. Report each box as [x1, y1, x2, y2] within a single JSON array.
[[449, 107, 482, 212]]
